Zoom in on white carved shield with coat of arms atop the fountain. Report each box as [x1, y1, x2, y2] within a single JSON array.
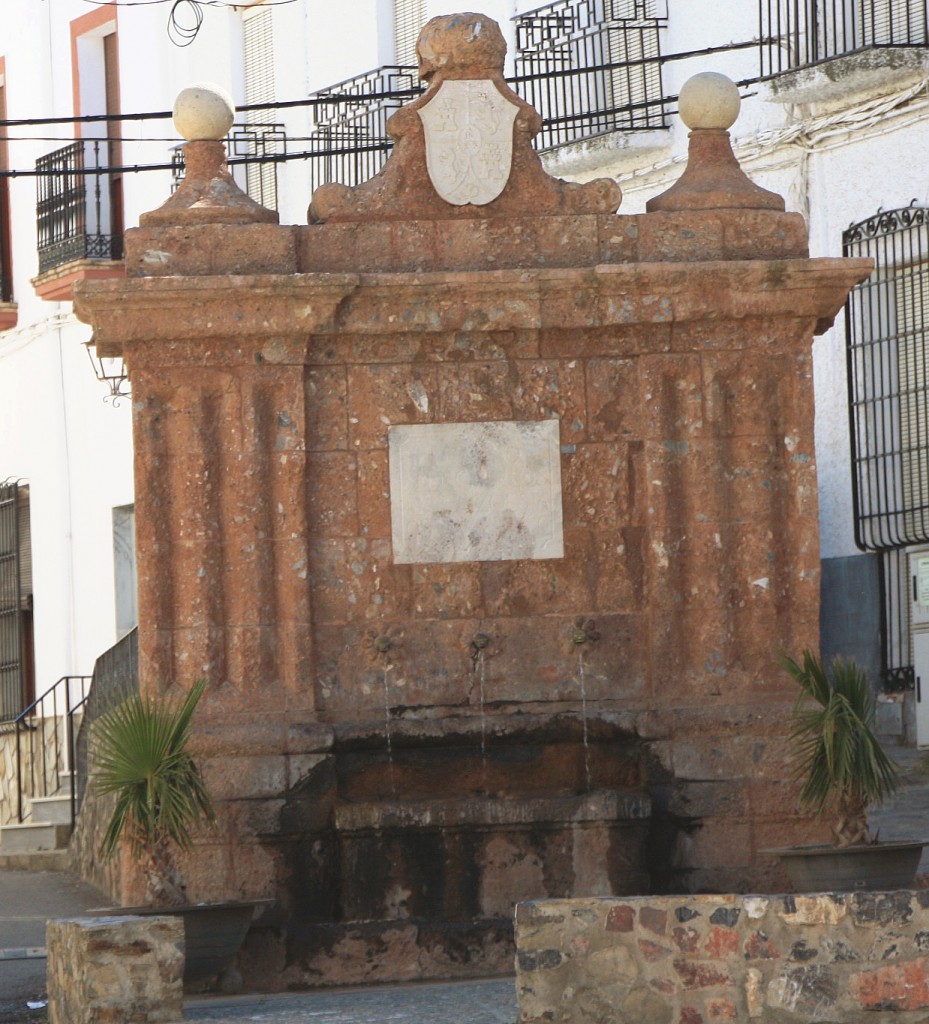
[[419, 79, 518, 206]]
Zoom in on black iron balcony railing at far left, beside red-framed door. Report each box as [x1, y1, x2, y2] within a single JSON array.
[[36, 139, 123, 273]]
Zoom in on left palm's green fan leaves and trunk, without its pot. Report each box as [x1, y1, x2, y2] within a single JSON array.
[[91, 680, 215, 906]]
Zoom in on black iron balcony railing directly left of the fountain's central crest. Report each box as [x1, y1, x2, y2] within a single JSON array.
[[307, 67, 421, 190]]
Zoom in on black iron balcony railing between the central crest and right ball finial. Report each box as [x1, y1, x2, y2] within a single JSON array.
[[515, 0, 667, 150]]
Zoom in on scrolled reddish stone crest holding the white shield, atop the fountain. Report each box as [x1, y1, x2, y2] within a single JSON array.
[[308, 13, 622, 223]]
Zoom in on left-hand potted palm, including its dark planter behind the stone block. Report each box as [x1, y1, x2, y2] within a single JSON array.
[[90, 680, 266, 985]]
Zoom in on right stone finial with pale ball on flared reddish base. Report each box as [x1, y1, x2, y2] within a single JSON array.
[[645, 72, 784, 213]]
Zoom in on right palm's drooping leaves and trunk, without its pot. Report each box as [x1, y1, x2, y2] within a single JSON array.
[[782, 650, 899, 847]]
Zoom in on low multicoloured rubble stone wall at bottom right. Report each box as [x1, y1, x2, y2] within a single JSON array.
[[516, 891, 929, 1024]]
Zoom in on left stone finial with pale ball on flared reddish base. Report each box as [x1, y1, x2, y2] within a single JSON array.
[[139, 82, 278, 227]]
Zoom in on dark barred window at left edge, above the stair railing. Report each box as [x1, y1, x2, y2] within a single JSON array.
[[0, 481, 32, 721]]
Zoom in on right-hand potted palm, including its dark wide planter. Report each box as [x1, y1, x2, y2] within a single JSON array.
[[765, 650, 924, 892]]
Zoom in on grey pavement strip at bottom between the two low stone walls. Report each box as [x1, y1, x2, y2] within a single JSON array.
[[184, 978, 519, 1024]]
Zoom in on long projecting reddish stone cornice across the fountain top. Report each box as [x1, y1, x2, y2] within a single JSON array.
[[75, 258, 872, 362]]
